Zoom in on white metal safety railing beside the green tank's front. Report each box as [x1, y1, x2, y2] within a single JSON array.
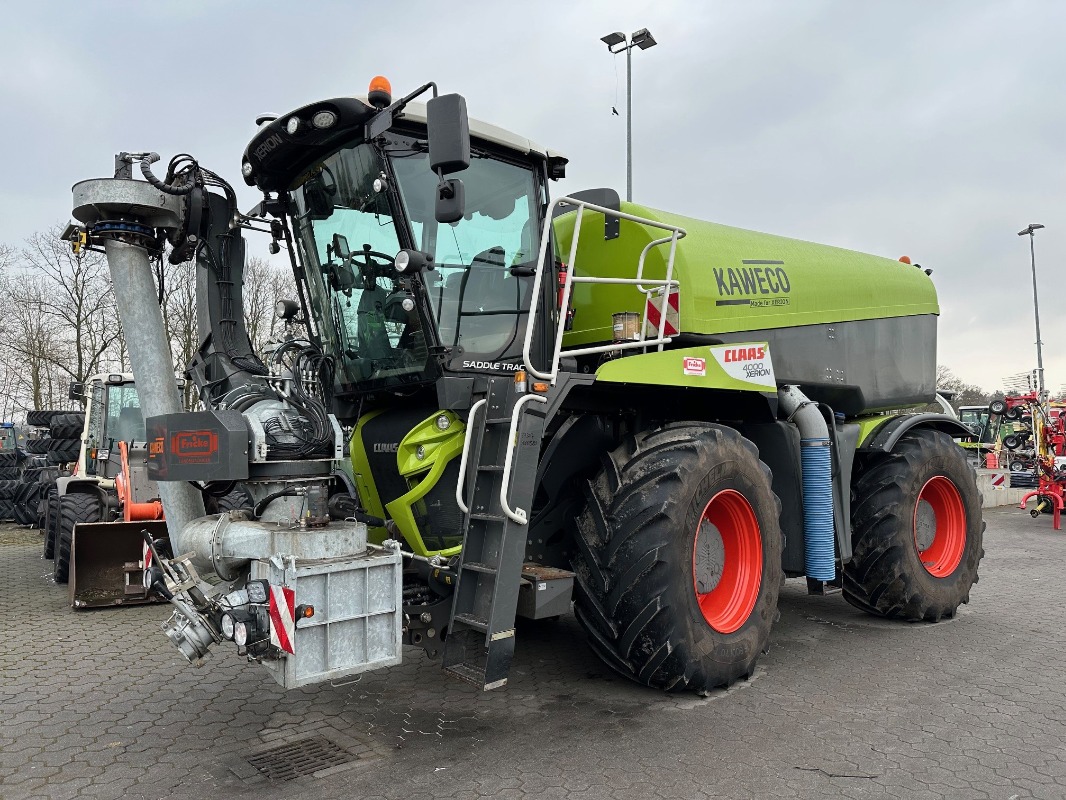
[[522, 196, 685, 385]]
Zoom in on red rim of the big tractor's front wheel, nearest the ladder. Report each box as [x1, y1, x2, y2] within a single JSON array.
[[692, 489, 762, 634]]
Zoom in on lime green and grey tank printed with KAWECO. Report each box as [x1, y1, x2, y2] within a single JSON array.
[[554, 203, 939, 416]]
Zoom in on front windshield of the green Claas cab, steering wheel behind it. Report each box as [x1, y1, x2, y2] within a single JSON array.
[[291, 144, 429, 390]]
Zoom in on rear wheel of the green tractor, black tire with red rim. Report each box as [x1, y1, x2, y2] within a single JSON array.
[[843, 430, 985, 622]]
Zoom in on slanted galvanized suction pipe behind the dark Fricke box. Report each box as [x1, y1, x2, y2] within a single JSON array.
[[104, 240, 205, 539]]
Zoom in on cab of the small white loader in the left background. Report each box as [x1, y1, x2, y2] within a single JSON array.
[[79, 373, 147, 479]]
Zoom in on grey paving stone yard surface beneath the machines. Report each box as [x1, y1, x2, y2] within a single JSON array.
[[0, 509, 1066, 800]]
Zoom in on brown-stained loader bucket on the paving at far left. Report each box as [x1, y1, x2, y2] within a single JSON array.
[[68, 522, 166, 609]]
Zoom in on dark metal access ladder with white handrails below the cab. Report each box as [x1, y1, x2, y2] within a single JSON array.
[[443, 378, 547, 690]]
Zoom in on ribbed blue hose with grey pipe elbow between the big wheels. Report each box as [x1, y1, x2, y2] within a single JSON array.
[[777, 385, 837, 580]]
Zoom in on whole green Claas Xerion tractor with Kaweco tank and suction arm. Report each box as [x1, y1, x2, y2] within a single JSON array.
[[66, 78, 984, 691]]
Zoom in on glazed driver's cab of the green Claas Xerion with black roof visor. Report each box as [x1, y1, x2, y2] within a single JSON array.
[[245, 86, 554, 399]]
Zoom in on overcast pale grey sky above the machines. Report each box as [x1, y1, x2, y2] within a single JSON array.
[[0, 0, 1066, 389]]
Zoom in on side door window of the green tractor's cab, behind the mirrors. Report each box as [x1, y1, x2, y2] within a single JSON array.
[[389, 138, 539, 363]]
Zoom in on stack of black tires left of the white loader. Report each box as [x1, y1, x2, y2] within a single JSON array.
[[12, 411, 85, 530]]
